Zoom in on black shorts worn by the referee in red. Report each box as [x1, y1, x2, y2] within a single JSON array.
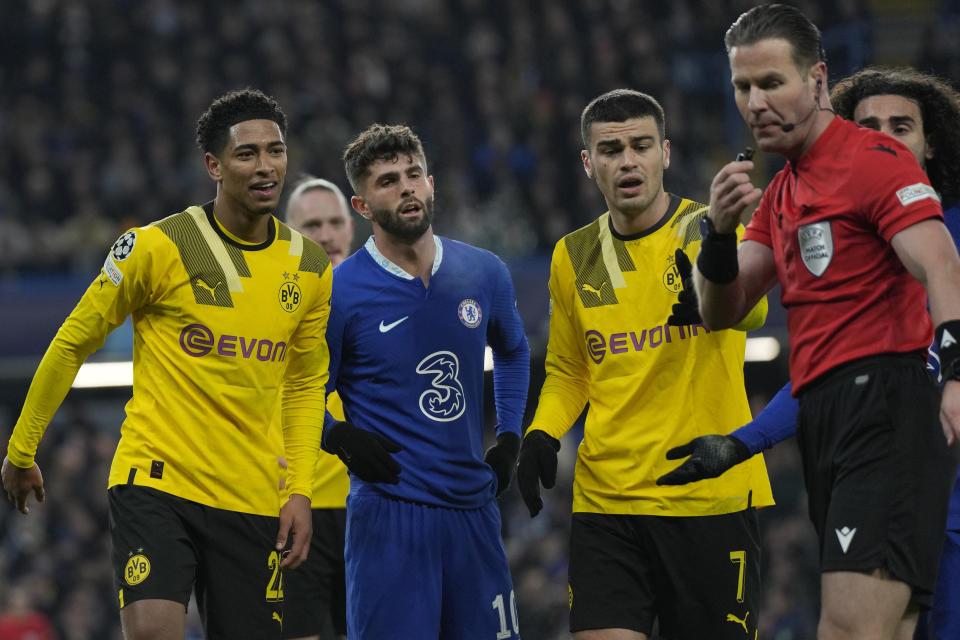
[[797, 354, 957, 609]]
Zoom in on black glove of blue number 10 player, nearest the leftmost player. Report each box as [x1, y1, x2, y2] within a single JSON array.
[[323, 422, 403, 484]]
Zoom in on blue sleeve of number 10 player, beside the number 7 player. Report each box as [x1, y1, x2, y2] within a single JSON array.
[[487, 259, 530, 436]]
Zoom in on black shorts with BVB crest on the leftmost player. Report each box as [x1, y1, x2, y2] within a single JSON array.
[[108, 485, 283, 640]]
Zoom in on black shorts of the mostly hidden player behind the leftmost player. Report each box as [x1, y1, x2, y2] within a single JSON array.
[[283, 509, 347, 638]]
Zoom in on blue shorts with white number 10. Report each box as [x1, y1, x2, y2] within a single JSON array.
[[344, 494, 520, 640]]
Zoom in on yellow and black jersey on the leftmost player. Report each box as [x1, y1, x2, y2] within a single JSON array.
[[8, 203, 331, 515]]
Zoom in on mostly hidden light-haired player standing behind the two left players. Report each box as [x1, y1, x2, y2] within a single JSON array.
[[283, 178, 354, 640]]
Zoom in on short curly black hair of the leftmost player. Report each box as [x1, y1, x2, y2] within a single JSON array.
[[197, 87, 287, 154]]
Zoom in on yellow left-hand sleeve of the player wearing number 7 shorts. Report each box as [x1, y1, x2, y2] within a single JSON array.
[[528, 240, 590, 439]]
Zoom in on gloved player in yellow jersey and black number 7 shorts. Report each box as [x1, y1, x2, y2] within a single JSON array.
[[517, 89, 773, 640]]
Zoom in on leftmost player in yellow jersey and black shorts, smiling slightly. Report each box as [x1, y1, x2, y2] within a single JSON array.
[[0, 89, 332, 640]]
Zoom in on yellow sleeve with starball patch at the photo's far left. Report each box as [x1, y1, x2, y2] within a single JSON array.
[[7, 230, 151, 469]]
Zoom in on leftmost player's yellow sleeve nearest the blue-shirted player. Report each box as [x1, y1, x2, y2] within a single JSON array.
[[282, 266, 333, 498]]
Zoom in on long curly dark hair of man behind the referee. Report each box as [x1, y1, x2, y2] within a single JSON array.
[[830, 67, 960, 202]]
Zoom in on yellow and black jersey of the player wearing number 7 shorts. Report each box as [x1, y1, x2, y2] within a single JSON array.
[[530, 196, 773, 516]]
